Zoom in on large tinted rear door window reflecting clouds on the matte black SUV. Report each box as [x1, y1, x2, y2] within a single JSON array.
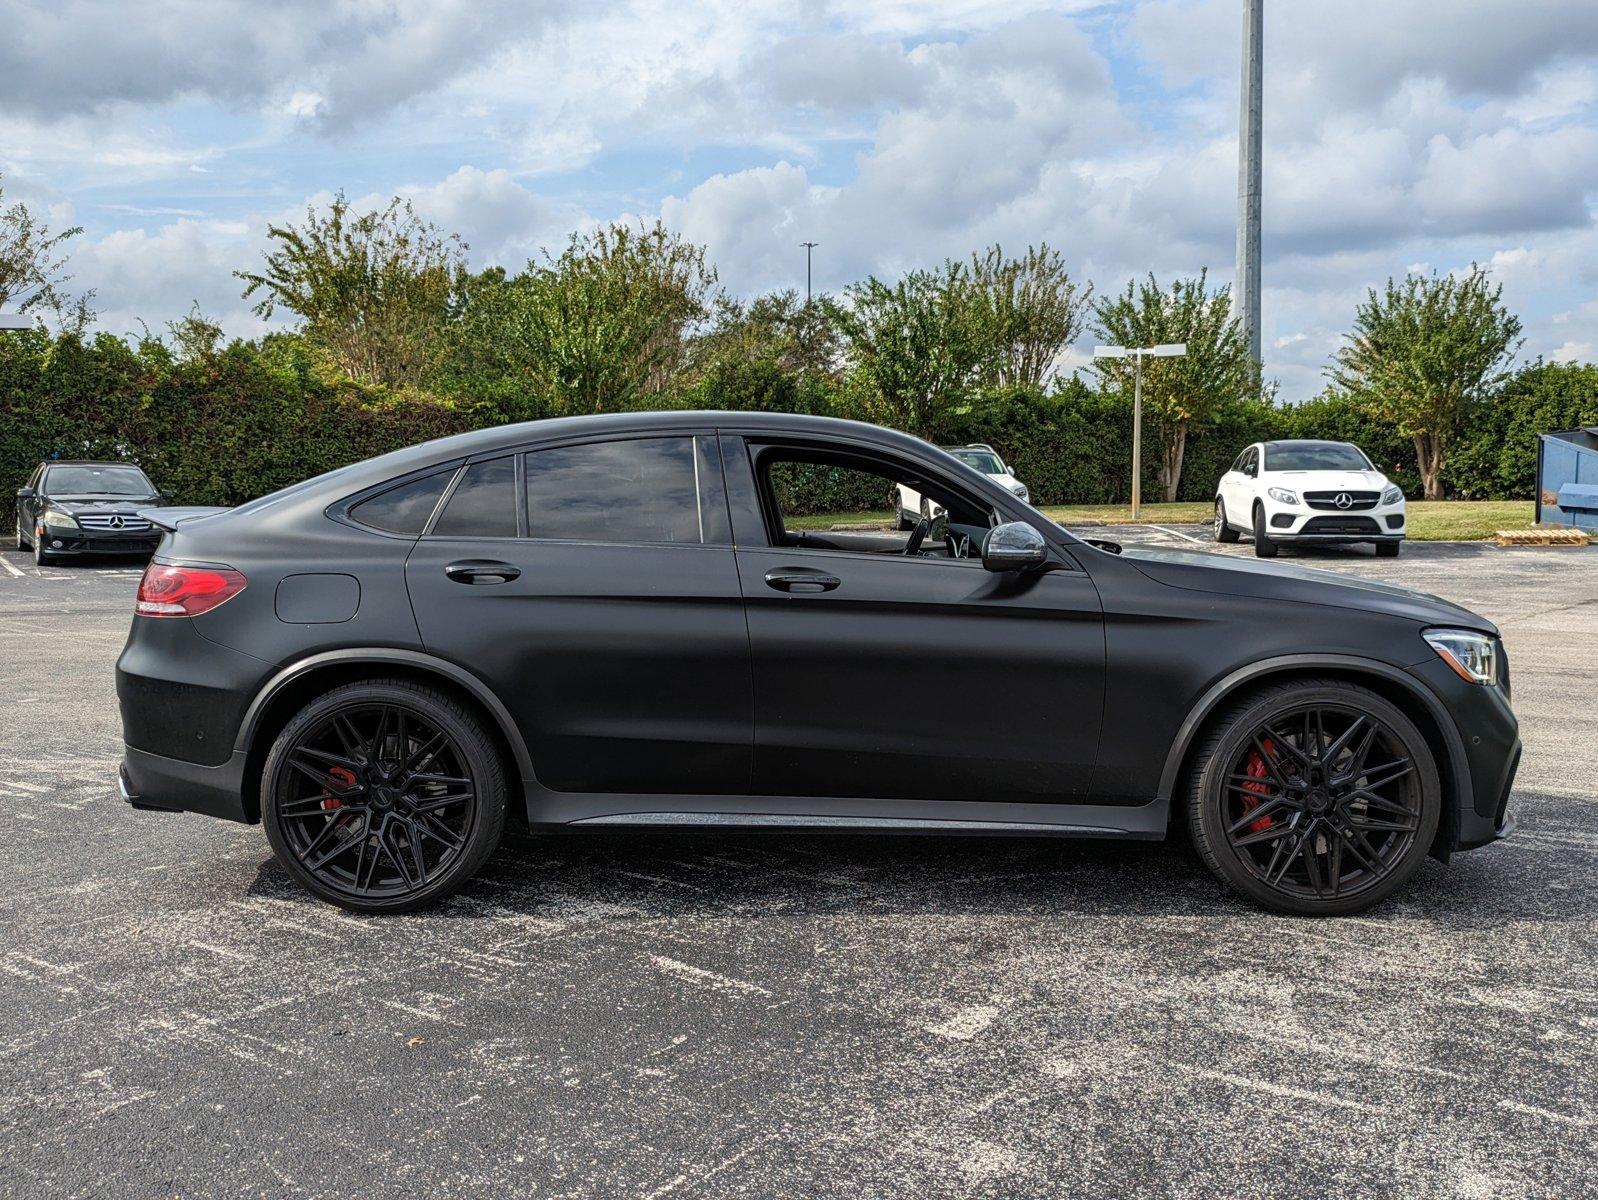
[[527, 438, 702, 543]]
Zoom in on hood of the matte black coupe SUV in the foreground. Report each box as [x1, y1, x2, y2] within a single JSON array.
[[1120, 546, 1497, 636]]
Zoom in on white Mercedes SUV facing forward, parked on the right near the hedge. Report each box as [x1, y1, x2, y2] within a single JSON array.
[[1214, 439, 1405, 558]]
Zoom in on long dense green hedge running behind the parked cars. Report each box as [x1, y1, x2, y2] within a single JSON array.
[[0, 331, 1598, 511]]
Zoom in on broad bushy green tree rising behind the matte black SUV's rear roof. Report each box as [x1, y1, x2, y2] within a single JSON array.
[[447, 222, 716, 415]]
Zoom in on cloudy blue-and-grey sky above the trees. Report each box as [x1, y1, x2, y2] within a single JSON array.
[[0, 0, 1598, 399]]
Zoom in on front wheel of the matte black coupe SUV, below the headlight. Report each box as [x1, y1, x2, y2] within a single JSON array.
[[1187, 679, 1443, 917]]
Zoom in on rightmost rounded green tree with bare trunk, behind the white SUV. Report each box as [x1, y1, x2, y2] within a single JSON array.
[[1328, 264, 1520, 500]]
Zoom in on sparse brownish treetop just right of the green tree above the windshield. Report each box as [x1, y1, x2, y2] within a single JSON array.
[[972, 241, 1093, 388]]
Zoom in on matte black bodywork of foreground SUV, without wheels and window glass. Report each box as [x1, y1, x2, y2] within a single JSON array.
[[117, 412, 1520, 907]]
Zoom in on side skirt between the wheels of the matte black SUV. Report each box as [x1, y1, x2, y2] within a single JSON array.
[[524, 783, 1170, 840]]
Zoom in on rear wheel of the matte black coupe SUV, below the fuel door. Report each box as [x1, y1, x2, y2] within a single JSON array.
[[260, 679, 507, 912]]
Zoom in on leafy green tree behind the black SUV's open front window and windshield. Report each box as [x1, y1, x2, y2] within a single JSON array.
[[828, 262, 984, 439]]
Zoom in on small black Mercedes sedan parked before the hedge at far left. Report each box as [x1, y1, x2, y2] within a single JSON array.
[[16, 460, 171, 566]]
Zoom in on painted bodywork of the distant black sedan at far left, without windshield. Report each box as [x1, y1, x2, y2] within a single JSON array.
[[16, 459, 169, 559]]
